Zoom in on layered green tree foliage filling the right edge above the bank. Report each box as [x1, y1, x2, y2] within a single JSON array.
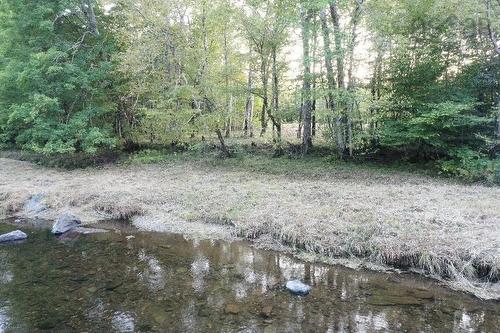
[[367, 0, 500, 180]]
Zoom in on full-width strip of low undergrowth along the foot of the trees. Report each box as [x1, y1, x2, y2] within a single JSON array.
[[0, 139, 500, 184]]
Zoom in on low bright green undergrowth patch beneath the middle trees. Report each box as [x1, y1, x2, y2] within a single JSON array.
[[120, 142, 446, 182]]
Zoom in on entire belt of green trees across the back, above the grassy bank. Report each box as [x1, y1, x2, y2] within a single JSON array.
[[0, 0, 500, 182]]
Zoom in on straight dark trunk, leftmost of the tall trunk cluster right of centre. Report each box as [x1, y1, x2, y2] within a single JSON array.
[[301, 8, 312, 155]]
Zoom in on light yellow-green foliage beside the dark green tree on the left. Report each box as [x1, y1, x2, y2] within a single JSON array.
[[113, 0, 246, 144]]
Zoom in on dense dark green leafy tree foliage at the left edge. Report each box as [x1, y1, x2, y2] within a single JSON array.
[[0, 0, 117, 154]]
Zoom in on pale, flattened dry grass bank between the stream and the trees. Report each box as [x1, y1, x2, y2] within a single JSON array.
[[0, 159, 500, 299]]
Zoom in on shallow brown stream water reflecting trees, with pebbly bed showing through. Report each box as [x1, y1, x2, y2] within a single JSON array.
[[0, 222, 500, 333]]
